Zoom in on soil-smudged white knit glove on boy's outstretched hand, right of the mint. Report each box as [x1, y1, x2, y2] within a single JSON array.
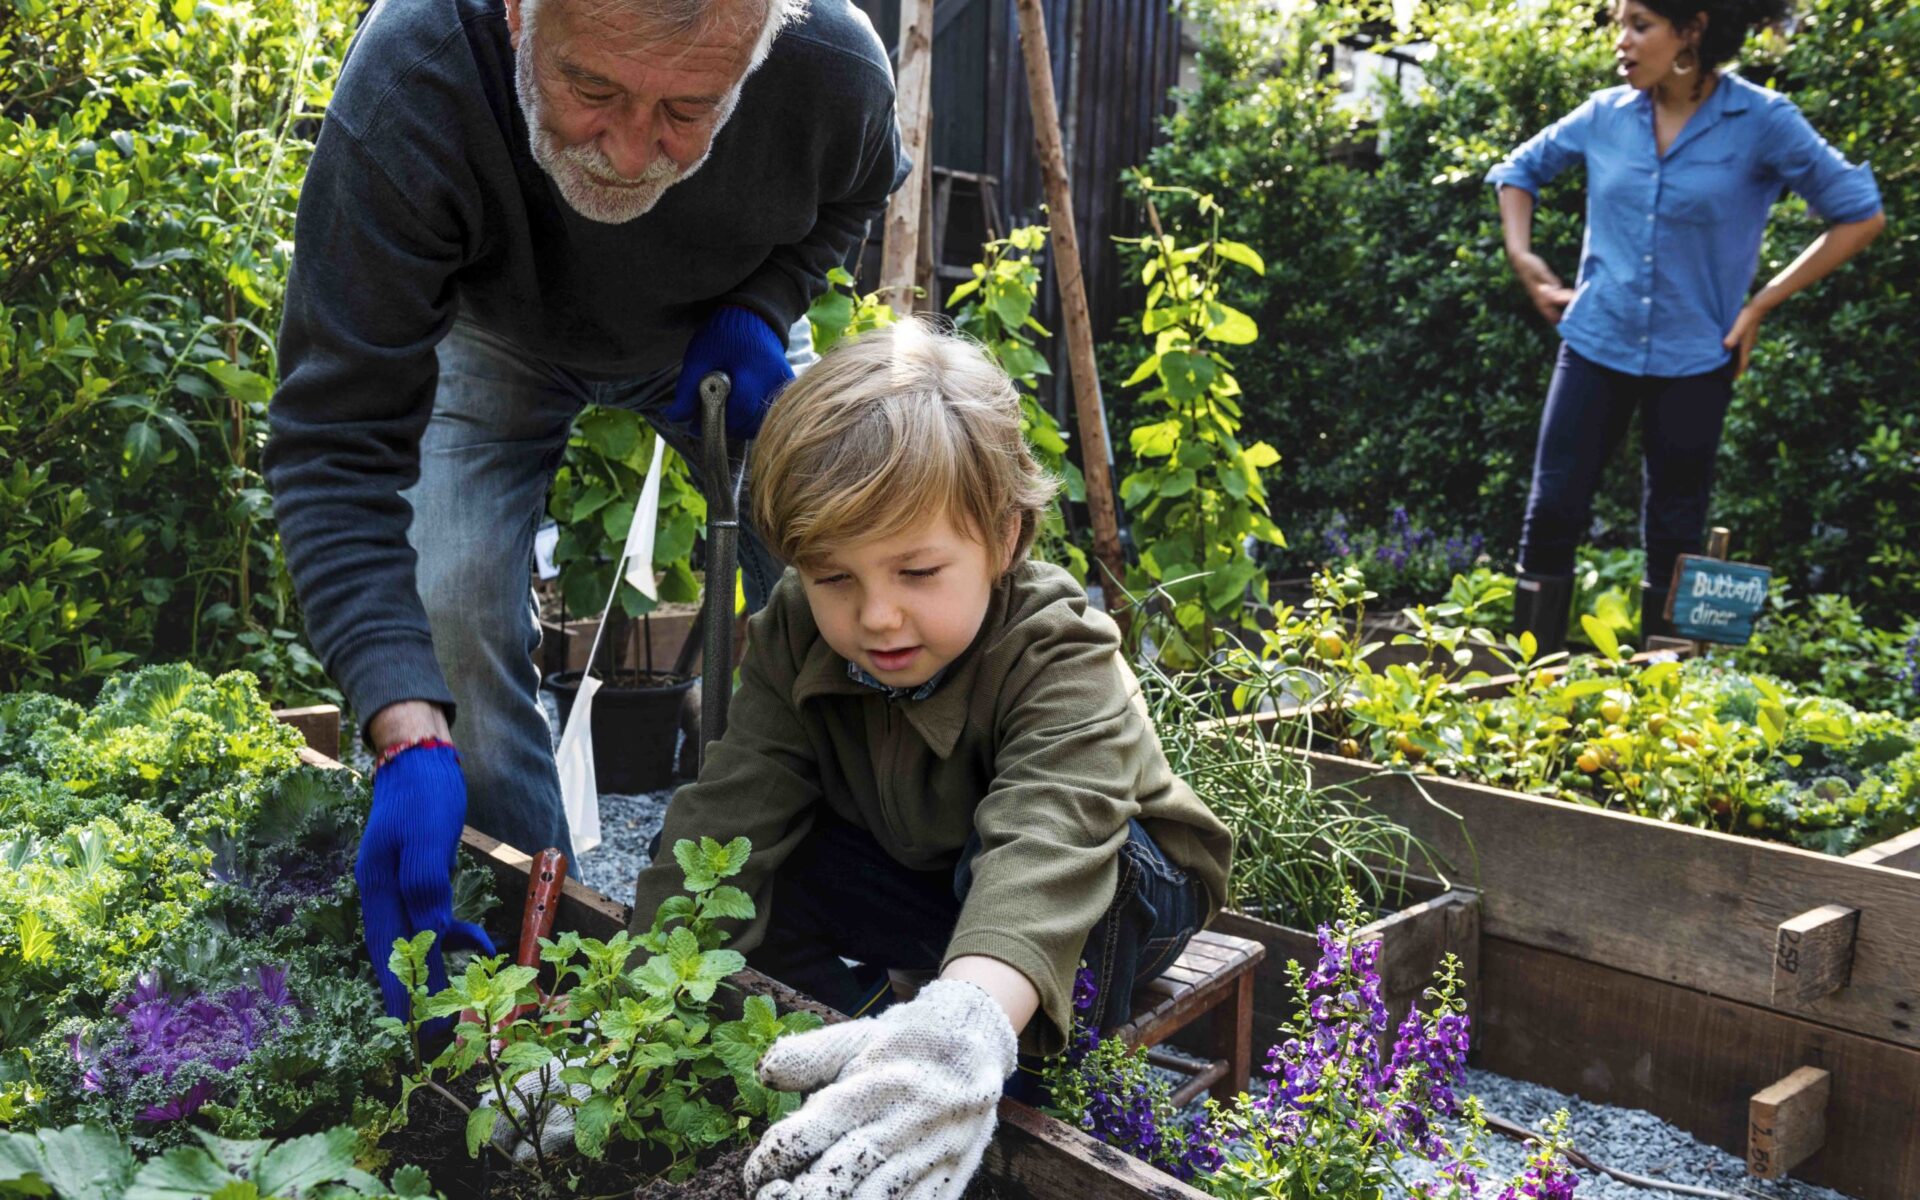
[[743, 979, 1016, 1200]]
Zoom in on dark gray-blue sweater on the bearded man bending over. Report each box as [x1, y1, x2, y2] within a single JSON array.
[[265, 0, 906, 722]]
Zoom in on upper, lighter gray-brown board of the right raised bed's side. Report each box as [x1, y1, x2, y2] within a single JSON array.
[[1308, 753, 1920, 1044]]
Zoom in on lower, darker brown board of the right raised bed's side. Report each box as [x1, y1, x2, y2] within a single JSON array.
[[1473, 935, 1920, 1200]]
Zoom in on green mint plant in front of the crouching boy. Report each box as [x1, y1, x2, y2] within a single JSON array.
[[386, 837, 820, 1187]]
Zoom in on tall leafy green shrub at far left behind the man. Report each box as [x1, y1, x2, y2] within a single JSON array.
[[0, 0, 363, 699]]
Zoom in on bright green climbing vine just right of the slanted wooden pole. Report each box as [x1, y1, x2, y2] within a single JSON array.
[[1119, 173, 1286, 668]]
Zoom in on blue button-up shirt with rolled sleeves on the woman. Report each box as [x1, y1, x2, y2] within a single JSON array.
[[1486, 75, 1880, 376]]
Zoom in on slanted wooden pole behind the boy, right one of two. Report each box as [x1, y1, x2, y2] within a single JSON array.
[[1020, 0, 1127, 609]]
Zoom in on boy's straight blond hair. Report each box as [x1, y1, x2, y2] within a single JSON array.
[[753, 321, 1060, 568]]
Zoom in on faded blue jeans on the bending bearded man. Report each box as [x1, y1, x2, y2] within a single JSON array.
[[403, 312, 814, 876]]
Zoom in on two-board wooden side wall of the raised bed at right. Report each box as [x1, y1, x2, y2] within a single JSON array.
[[1306, 753, 1920, 1200]]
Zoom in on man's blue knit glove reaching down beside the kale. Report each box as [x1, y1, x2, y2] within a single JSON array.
[[353, 745, 493, 1020]]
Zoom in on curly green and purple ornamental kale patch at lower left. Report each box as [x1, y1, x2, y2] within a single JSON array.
[[0, 664, 488, 1148]]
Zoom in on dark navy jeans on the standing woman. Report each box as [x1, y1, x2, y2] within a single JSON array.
[[1521, 342, 1734, 588]]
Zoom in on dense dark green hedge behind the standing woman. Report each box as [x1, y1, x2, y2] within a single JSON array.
[[1150, 0, 1920, 609]]
